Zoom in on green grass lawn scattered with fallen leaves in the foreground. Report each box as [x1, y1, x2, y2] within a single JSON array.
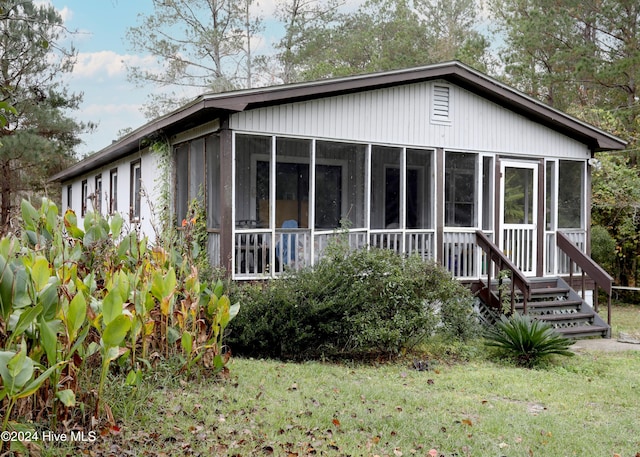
[[43, 308, 640, 457]]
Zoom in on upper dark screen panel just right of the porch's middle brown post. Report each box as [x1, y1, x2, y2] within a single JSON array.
[[444, 152, 477, 227]]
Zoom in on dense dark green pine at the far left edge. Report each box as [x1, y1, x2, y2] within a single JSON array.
[[0, 0, 90, 233]]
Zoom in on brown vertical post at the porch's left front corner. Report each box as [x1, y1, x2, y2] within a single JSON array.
[[220, 116, 233, 276]]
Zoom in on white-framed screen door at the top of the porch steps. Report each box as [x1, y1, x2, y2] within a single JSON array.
[[499, 161, 538, 275]]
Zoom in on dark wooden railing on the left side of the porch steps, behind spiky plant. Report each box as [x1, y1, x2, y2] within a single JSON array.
[[476, 230, 531, 314]]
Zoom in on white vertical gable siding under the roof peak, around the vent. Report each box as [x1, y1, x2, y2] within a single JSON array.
[[231, 82, 590, 160]]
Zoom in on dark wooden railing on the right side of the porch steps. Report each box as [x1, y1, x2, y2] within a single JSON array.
[[556, 232, 613, 325]]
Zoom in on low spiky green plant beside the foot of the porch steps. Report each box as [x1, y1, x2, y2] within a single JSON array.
[[487, 313, 573, 368]]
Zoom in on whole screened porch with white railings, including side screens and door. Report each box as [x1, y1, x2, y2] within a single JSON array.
[[175, 132, 588, 279]]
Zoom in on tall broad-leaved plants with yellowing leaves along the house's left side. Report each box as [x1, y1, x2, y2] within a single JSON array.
[[0, 199, 239, 446]]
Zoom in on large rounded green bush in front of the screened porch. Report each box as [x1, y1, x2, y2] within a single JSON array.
[[228, 249, 477, 359]]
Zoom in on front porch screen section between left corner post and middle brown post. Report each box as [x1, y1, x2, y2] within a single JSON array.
[[233, 133, 435, 278]]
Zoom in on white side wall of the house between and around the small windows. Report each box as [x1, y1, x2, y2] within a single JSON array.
[[62, 149, 159, 242]]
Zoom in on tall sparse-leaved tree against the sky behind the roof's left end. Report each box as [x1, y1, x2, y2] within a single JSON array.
[[126, 0, 261, 118]]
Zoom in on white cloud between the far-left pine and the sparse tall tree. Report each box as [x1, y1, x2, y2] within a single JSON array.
[[73, 51, 155, 78]]
